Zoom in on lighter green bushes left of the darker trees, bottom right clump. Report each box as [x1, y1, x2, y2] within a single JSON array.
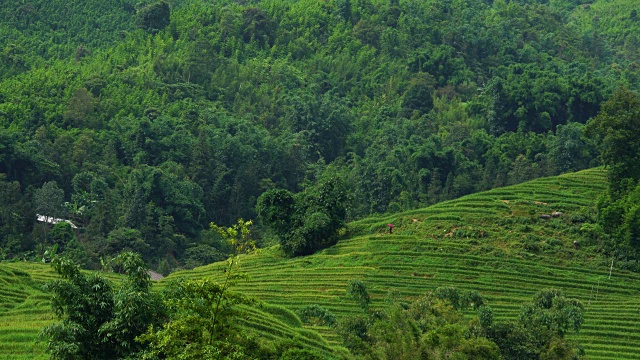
[[338, 282, 500, 360]]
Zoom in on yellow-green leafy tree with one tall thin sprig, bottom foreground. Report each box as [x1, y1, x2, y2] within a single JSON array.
[[139, 219, 253, 359]]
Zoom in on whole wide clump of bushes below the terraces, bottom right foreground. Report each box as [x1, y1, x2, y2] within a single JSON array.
[[338, 287, 584, 360]]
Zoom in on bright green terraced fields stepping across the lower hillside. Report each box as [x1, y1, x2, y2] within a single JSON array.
[[0, 169, 640, 359]]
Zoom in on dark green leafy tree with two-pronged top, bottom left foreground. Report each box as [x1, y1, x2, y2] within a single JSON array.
[[42, 253, 163, 359]]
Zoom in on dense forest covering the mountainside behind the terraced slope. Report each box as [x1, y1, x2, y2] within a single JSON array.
[[0, 0, 640, 273]]
